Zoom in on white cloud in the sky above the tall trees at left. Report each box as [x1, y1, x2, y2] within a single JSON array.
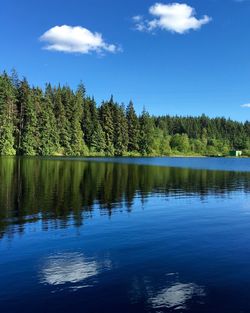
[[40, 25, 119, 54]]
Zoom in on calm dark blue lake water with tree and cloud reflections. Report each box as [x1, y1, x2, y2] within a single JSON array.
[[0, 158, 250, 313]]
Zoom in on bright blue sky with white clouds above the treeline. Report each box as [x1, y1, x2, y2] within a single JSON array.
[[0, 0, 250, 120]]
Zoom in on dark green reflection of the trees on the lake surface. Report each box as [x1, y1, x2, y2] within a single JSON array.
[[0, 157, 250, 236]]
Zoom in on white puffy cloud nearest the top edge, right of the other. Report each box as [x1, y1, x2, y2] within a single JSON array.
[[133, 3, 212, 34]]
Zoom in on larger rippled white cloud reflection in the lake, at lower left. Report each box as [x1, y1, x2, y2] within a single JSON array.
[[41, 253, 99, 286]]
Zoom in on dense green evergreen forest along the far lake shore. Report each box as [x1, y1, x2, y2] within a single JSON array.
[[0, 71, 250, 156]]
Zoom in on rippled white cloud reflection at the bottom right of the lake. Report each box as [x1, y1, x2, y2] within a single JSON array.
[[149, 283, 205, 310]]
